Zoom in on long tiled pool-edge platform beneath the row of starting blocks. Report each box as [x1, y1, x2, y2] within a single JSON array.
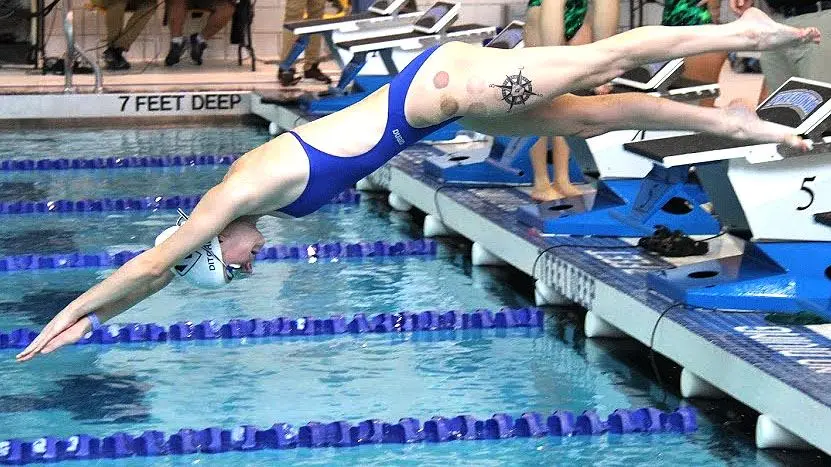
[[365, 145, 831, 454]]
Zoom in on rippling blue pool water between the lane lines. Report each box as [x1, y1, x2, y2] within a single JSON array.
[[0, 123, 808, 466]]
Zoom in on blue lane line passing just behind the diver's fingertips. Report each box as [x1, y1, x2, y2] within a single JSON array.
[[0, 308, 544, 349]]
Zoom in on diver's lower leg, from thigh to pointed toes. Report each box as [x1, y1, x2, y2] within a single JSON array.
[[461, 93, 809, 149]]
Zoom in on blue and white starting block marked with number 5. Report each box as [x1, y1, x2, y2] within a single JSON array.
[[627, 78, 831, 319]]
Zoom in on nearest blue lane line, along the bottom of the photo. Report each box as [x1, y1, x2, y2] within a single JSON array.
[[0, 407, 698, 465]]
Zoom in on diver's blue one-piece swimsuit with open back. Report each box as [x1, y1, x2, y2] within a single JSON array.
[[278, 46, 459, 217]]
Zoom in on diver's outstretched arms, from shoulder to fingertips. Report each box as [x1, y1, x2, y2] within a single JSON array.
[[16, 179, 256, 361]]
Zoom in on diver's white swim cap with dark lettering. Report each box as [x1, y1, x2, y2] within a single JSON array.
[[156, 209, 232, 289]]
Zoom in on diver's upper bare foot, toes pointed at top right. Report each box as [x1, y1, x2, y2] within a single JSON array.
[[735, 8, 822, 50]]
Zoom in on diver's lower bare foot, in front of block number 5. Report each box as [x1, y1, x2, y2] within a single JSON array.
[[723, 99, 811, 151]]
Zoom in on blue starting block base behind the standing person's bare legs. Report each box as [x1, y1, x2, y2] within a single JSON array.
[[424, 136, 586, 186]]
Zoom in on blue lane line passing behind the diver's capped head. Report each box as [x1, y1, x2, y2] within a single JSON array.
[[0, 239, 438, 272]]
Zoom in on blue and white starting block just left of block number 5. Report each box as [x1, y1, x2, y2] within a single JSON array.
[[517, 65, 720, 237]]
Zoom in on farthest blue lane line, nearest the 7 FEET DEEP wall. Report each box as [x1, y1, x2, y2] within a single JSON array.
[[0, 154, 242, 172]]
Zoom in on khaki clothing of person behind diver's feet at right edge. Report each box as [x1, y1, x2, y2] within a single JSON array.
[[761, 10, 831, 92]]
